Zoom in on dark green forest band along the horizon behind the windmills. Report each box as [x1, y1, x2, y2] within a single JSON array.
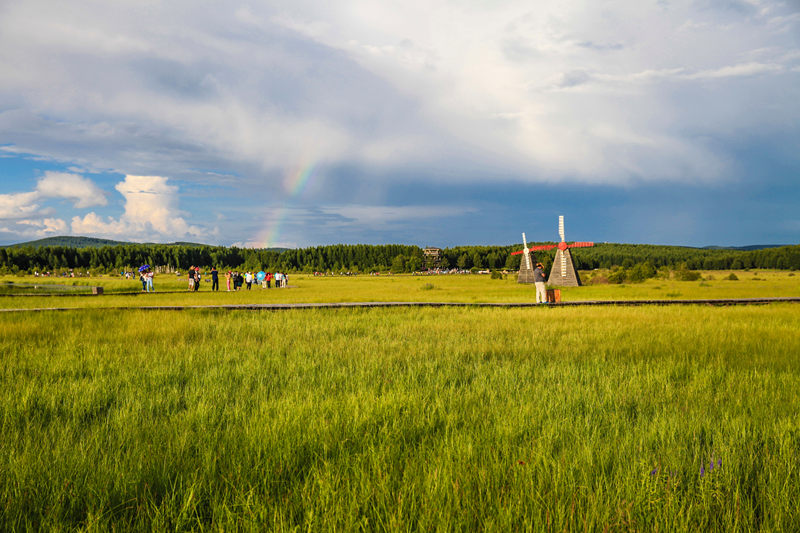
[[0, 243, 800, 273]]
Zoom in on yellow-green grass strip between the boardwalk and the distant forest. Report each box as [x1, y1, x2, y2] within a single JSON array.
[[0, 271, 800, 308]]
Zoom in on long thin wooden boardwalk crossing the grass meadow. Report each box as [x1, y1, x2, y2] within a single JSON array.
[[0, 298, 800, 313]]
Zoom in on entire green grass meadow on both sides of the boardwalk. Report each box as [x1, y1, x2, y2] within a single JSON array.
[[0, 273, 800, 531]]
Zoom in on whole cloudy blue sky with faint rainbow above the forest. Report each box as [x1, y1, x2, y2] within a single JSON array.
[[0, 0, 800, 247]]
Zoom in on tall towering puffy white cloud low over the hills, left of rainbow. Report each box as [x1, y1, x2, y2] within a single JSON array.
[[71, 175, 206, 241]]
